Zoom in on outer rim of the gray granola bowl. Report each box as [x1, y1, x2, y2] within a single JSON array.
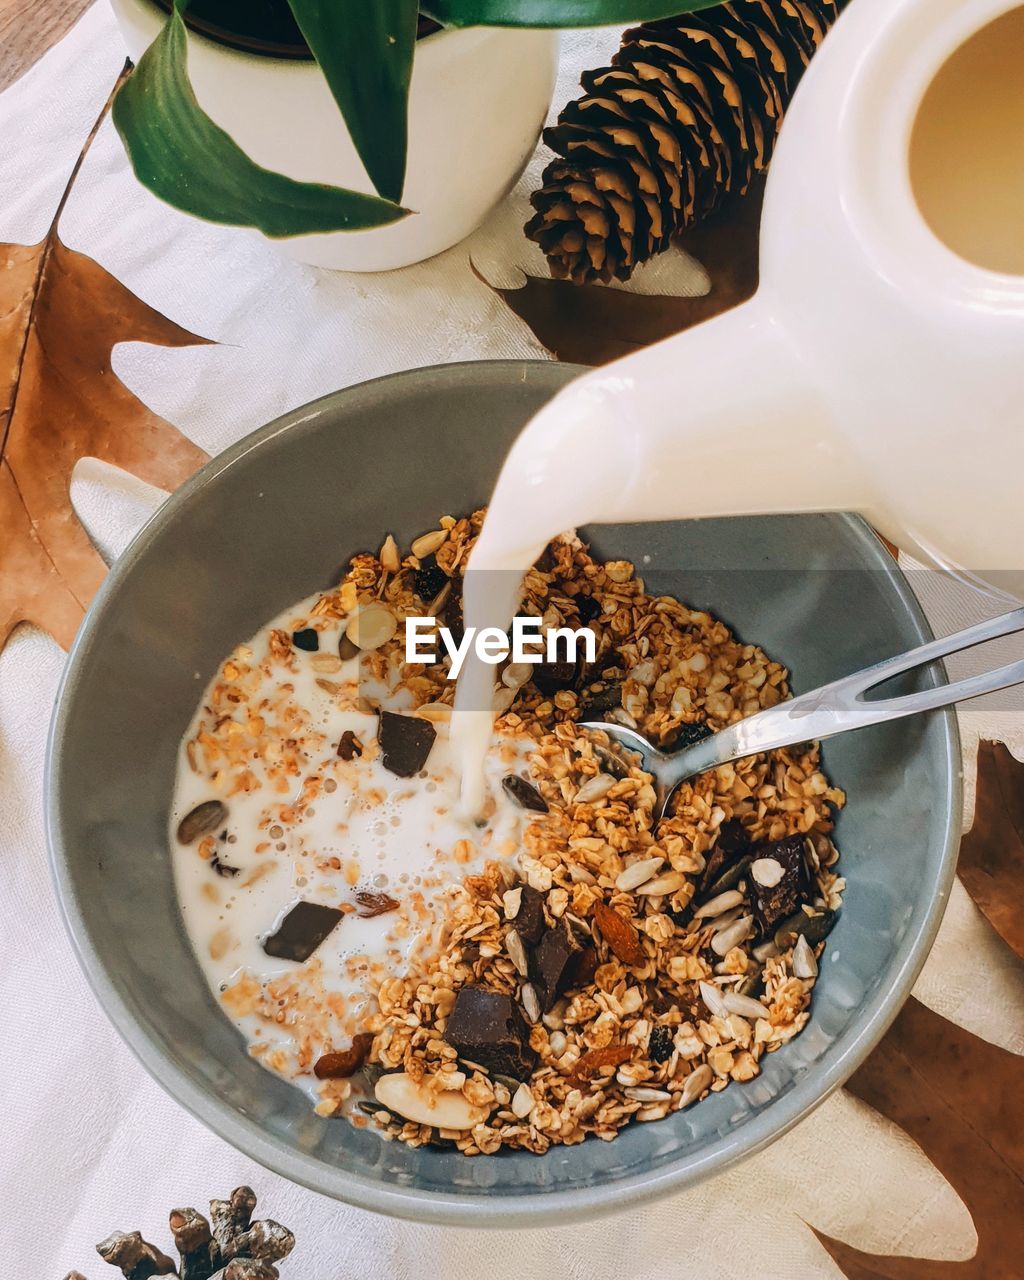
[[45, 360, 963, 1229]]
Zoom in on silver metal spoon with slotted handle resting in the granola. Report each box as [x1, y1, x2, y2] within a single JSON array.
[[580, 608, 1024, 820]]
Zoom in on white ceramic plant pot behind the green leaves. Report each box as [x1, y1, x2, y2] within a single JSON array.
[[113, 0, 558, 271]]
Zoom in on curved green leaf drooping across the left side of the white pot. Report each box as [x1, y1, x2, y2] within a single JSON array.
[[111, 0, 407, 237]]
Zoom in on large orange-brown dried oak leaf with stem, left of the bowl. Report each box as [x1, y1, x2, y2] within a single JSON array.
[[0, 64, 207, 648]]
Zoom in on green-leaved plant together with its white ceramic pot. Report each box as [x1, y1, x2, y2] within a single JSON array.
[[113, 0, 708, 271]]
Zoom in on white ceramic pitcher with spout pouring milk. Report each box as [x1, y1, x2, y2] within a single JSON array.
[[492, 0, 1024, 594]]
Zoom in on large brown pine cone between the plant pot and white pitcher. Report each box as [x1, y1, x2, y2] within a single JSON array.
[[526, 0, 847, 284]]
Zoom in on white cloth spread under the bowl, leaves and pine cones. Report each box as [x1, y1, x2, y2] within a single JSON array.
[[0, 0, 1024, 1280]]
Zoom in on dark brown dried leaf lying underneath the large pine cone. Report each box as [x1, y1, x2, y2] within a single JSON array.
[[474, 182, 764, 365]]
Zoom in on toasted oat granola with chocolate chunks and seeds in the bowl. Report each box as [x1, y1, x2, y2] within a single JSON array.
[[170, 512, 845, 1155]]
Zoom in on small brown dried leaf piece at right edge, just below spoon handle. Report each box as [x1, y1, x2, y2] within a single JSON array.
[[957, 742, 1024, 959]]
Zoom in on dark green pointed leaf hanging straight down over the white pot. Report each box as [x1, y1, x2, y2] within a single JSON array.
[[288, 0, 420, 201]]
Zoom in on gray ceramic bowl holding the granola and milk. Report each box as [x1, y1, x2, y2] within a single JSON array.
[[47, 362, 960, 1226]]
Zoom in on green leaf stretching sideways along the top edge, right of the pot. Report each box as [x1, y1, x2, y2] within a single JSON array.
[[420, 0, 718, 27]]
